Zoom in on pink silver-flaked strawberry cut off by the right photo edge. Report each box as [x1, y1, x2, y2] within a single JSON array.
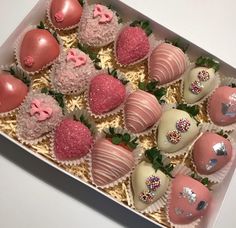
[[208, 86, 236, 126]]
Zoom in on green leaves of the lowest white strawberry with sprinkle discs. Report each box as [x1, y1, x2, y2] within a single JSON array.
[[145, 147, 174, 178]]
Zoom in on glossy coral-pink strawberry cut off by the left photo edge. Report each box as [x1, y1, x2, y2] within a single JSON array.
[[0, 72, 28, 113]]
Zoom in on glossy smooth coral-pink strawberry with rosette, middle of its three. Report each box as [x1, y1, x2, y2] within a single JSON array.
[[17, 29, 60, 73]]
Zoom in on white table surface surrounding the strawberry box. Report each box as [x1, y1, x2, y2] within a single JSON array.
[[0, 0, 236, 228]]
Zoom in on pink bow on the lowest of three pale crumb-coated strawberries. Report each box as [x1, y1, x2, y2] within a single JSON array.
[[30, 99, 52, 122]]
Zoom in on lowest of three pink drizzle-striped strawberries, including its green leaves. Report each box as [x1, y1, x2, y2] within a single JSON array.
[[91, 128, 137, 187]]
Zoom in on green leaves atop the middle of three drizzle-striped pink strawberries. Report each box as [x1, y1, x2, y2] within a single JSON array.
[[138, 81, 167, 103]]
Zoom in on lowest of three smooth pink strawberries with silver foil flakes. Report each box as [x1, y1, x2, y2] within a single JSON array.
[[168, 175, 212, 224]]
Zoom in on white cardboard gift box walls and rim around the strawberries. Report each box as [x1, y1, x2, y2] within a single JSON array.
[[0, 0, 236, 227]]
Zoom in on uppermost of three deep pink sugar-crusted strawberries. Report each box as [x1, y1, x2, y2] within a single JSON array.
[[115, 27, 150, 65]]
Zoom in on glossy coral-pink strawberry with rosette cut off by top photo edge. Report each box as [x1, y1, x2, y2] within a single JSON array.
[[48, 0, 83, 30]]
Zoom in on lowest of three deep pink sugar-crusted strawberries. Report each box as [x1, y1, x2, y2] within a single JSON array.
[[54, 119, 93, 161]]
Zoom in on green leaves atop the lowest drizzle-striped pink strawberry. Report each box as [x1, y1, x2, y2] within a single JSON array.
[[103, 127, 138, 150]]
